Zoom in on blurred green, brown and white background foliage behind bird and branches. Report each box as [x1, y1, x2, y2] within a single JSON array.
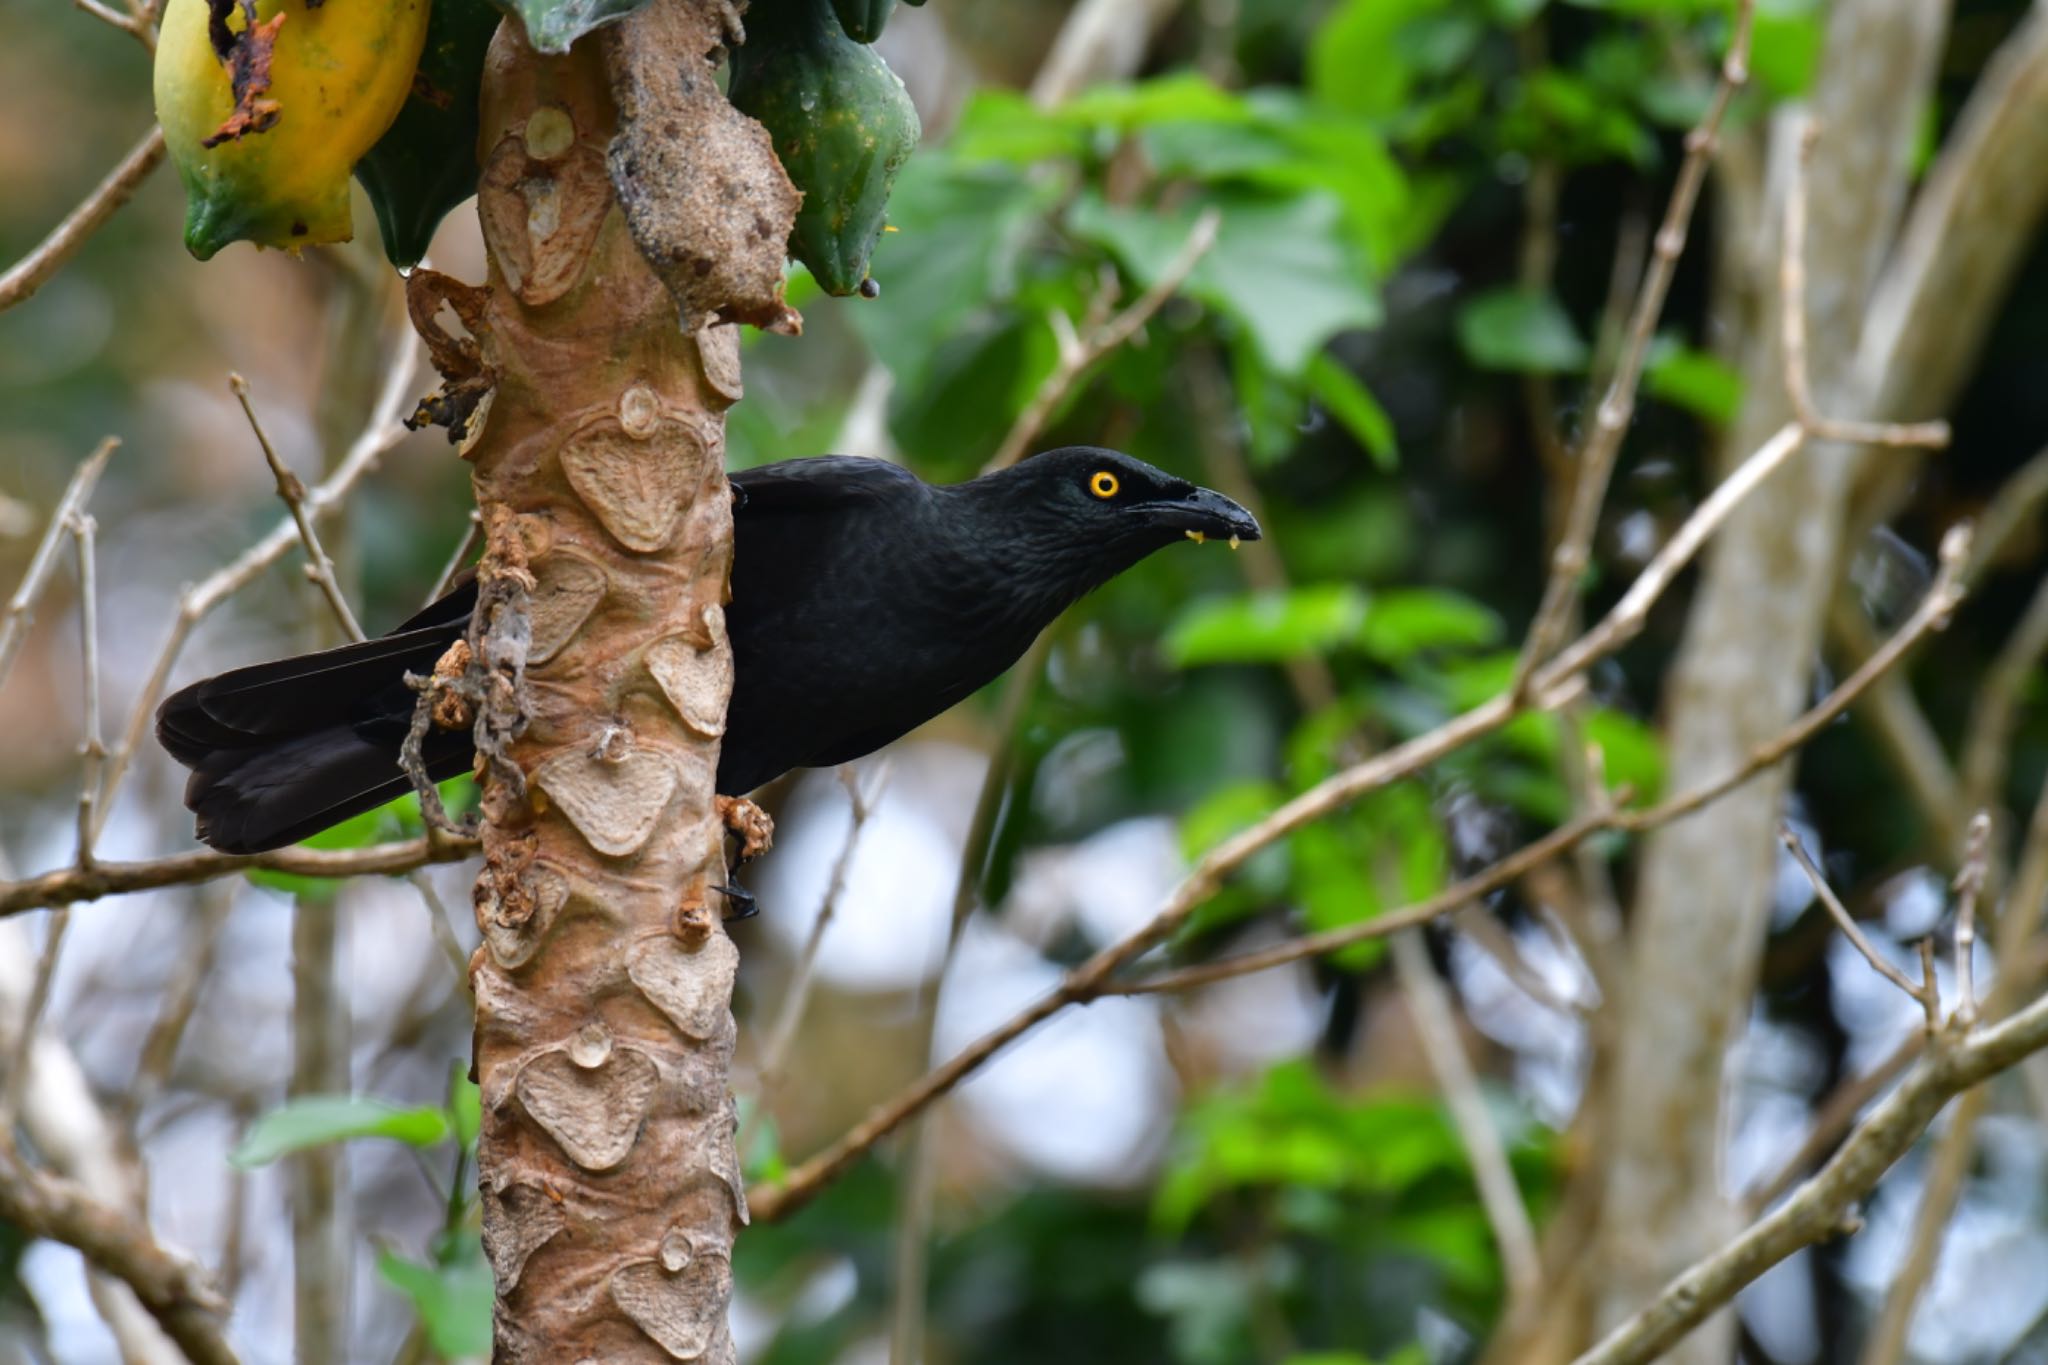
[[0, 0, 2048, 1365]]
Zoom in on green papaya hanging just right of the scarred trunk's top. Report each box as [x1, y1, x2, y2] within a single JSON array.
[[727, 0, 924, 297]]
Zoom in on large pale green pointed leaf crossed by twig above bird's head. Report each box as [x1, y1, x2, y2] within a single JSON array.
[[1067, 190, 1382, 379]]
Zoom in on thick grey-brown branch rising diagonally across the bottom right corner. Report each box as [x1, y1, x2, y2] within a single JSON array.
[[1573, 982, 2048, 1365]]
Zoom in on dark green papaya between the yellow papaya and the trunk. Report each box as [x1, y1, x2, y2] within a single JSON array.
[[356, 0, 502, 270]]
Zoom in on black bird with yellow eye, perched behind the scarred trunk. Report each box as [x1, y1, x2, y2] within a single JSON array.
[[156, 446, 1260, 853]]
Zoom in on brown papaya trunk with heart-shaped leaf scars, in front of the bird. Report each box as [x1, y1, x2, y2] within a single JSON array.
[[436, 0, 795, 1363]]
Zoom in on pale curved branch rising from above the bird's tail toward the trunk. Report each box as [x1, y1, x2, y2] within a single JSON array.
[[96, 334, 420, 843]]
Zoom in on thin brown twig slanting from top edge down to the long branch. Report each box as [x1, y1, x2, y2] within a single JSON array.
[[1511, 0, 1755, 698]]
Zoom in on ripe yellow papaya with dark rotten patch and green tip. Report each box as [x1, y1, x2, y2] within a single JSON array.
[[154, 0, 428, 260]]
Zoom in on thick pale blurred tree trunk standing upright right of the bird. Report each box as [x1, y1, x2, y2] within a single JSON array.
[[1595, 0, 1948, 1365]]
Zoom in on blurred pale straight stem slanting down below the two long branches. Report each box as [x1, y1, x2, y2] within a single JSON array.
[[1389, 929, 1542, 1304]]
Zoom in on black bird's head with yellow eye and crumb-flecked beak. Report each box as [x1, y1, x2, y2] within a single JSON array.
[[975, 446, 1260, 556]]
